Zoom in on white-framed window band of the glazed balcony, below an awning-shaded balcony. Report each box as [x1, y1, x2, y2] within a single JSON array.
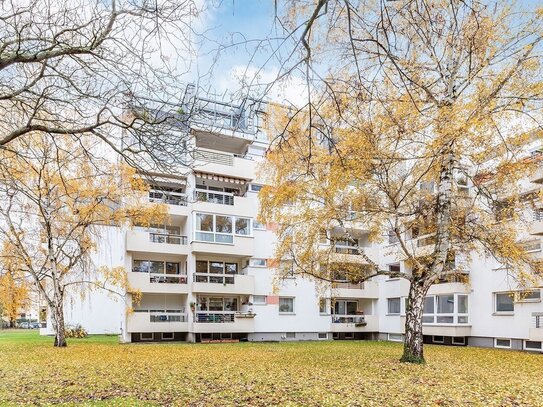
[[194, 213, 252, 244]]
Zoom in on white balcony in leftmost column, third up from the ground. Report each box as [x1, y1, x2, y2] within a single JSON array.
[[126, 230, 189, 256]]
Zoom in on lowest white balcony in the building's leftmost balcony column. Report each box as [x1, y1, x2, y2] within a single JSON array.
[[126, 309, 189, 332]]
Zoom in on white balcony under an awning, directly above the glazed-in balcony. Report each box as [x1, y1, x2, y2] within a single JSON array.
[[193, 189, 256, 217]]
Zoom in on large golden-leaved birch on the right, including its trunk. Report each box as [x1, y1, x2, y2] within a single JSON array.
[[262, 0, 543, 363]]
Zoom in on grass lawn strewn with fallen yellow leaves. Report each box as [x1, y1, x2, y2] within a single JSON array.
[[0, 331, 543, 406]]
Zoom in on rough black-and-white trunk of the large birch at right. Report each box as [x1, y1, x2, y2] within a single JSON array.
[[400, 279, 428, 364]]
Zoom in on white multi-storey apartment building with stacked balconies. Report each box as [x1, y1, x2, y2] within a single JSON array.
[[43, 91, 543, 352]]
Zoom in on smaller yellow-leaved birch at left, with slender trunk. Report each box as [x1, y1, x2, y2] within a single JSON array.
[[0, 134, 166, 347]]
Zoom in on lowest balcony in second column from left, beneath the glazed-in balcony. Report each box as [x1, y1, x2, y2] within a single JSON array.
[[193, 311, 255, 333]]
